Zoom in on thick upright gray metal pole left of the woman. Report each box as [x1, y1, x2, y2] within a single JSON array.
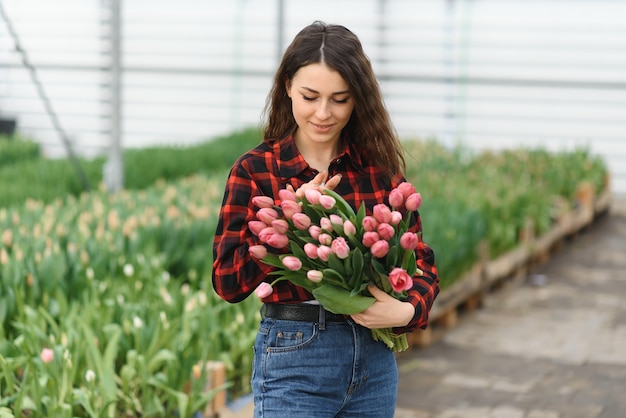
[[103, 0, 124, 193]]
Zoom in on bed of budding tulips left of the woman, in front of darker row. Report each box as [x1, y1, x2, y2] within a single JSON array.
[[0, 173, 259, 417]]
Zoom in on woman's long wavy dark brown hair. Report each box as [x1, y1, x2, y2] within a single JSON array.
[[264, 21, 405, 177]]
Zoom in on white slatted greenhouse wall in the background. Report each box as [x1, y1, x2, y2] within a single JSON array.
[[0, 0, 626, 194]]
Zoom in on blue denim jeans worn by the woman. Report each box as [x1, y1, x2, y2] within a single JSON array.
[[252, 312, 398, 418]]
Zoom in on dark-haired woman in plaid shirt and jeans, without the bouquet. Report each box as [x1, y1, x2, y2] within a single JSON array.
[[213, 22, 439, 418]]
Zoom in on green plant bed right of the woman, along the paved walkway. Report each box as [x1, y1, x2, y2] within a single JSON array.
[[406, 141, 608, 287]]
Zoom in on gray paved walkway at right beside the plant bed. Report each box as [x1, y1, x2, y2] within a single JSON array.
[[396, 198, 626, 418]]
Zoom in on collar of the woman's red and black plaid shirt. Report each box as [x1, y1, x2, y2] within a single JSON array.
[[271, 135, 363, 179]]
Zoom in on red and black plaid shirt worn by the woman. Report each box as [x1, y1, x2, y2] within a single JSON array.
[[213, 137, 439, 333]]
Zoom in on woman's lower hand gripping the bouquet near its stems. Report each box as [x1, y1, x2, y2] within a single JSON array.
[[350, 285, 415, 329]]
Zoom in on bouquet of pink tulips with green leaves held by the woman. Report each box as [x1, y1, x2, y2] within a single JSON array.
[[248, 182, 422, 351]]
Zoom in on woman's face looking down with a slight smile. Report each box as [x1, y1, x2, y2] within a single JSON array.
[[286, 64, 354, 149]]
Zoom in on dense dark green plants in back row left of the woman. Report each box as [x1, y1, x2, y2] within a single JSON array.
[[0, 128, 259, 207]]
